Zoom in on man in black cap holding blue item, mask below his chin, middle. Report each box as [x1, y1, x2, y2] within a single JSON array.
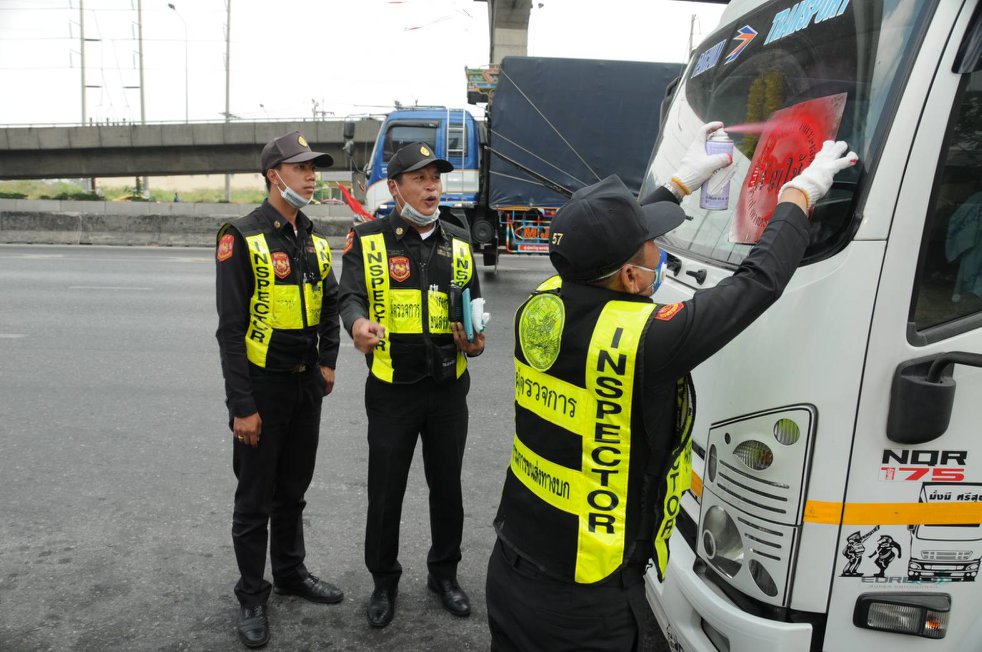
[[341, 143, 484, 627]]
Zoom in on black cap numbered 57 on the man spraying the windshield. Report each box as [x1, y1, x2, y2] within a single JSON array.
[[549, 175, 685, 281]]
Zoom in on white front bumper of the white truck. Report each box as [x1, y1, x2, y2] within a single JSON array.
[[645, 536, 812, 652]]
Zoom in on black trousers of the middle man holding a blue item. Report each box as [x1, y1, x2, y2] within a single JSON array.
[[365, 372, 470, 589]]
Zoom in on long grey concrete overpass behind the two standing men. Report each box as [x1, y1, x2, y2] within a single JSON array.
[[0, 119, 379, 179]]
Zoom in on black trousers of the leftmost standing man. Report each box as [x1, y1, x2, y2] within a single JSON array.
[[232, 366, 324, 607]]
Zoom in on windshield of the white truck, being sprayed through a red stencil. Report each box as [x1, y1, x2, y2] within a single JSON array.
[[639, 0, 935, 265]]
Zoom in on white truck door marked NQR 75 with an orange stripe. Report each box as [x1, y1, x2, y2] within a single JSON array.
[[825, 2, 982, 650]]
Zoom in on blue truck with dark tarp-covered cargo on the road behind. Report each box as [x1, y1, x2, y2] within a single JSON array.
[[354, 57, 682, 265]]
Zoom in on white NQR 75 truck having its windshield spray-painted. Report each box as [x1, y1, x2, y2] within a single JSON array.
[[640, 0, 982, 652]]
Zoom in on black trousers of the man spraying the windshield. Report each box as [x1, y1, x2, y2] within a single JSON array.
[[486, 540, 649, 652]]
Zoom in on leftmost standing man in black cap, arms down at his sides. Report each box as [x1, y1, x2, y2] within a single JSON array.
[[216, 131, 344, 647]]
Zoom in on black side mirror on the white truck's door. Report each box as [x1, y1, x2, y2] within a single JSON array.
[[887, 351, 982, 444]]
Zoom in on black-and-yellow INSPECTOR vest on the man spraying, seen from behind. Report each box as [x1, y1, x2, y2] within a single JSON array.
[[495, 278, 693, 584]]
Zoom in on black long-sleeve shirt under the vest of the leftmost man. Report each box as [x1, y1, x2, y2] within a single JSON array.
[[215, 201, 341, 417]]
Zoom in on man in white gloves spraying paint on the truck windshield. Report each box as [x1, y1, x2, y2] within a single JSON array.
[[487, 130, 856, 652]]
